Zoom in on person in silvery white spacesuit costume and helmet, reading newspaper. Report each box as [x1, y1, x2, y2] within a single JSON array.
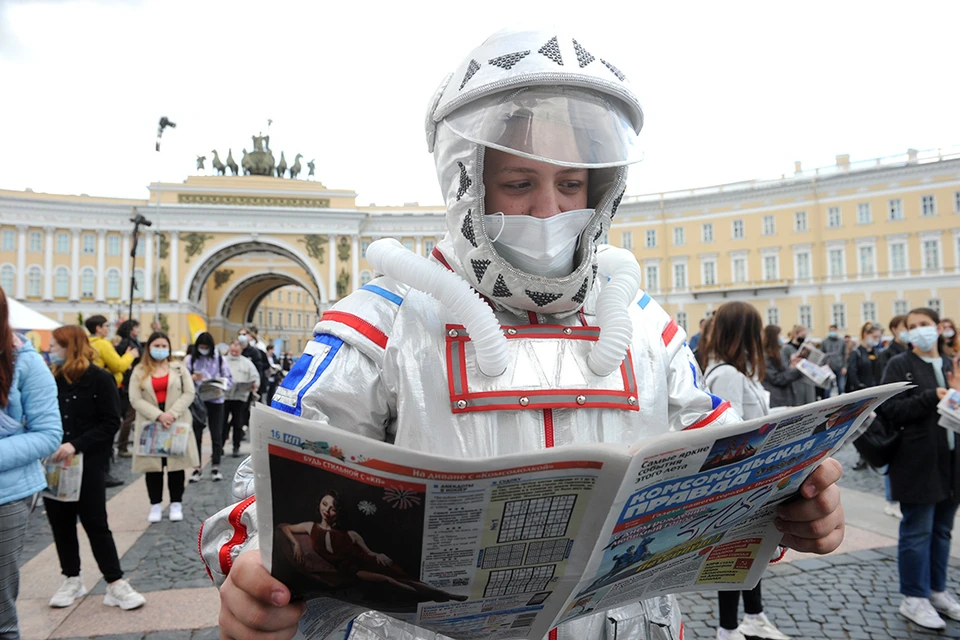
[[200, 31, 844, 640]]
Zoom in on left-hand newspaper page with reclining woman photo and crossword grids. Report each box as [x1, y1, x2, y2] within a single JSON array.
[[252, 406, 629, 639]]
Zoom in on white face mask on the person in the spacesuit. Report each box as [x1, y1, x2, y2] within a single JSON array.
[[484, 209, 595, 278]]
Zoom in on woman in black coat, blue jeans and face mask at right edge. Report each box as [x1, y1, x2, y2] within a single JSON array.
[[881, 308, 960, 629]]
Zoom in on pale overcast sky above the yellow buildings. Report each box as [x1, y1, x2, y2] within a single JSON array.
[[0, 0, 960, 205]]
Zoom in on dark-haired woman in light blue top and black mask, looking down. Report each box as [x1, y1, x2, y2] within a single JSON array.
[[183, 331, 233, 482]]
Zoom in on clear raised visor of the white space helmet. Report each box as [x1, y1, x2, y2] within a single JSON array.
[[444, 86, 643, 169]]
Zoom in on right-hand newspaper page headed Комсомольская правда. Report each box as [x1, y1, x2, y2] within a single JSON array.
[[561, 383, 908, 621]]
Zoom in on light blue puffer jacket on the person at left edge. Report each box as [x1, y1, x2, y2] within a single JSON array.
[[0, 336, 63, 504]]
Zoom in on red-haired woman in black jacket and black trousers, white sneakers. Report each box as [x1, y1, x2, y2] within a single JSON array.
[[44, 325, 147, 611]]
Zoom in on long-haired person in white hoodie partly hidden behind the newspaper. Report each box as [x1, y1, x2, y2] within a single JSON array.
[[698, 301, 788, 640]]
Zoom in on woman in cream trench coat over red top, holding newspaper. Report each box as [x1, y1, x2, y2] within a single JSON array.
[[130, 331, 200, 522]]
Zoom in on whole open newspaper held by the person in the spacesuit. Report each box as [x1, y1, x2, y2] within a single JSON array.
[[251, 383, 908, 639]]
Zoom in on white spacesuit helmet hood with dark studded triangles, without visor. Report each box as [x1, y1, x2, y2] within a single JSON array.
[[426, 31, 643, 316]]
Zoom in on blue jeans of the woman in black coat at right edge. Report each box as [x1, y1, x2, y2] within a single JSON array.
[[897, 500, 957, 598]]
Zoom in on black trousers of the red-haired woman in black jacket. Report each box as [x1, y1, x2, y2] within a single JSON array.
[[43, 458, 124, 583]]
